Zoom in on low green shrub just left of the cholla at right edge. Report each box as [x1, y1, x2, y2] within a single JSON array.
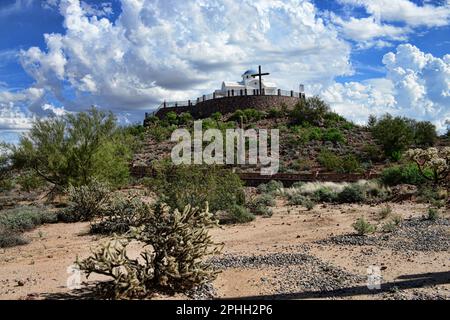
[[381, 164, 427, 186]]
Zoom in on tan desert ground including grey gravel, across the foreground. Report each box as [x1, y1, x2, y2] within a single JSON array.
[[0, 202, 450, 299]]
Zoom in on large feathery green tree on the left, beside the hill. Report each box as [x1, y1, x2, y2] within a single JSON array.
[[9, 108, 132, 191]]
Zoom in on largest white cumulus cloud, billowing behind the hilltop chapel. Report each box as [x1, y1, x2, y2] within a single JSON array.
[[16, 0, 352, 119]]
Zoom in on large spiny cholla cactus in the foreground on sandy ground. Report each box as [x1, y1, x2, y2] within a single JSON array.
[[77, 204, 220, 298]]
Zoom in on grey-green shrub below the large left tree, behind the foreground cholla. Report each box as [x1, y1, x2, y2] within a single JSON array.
[[58, 180, 111, 222]]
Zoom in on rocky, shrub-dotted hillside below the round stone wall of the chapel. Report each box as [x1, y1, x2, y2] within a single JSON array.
[[133, 98, 449, 178]]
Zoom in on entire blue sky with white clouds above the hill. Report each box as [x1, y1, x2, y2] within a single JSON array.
[[0, 0, 450, 142]]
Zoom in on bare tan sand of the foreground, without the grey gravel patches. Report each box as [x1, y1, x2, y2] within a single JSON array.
[[0, 202, 450, 299]]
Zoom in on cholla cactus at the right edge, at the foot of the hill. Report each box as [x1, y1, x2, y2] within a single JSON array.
[[406, 147, 450, 184]]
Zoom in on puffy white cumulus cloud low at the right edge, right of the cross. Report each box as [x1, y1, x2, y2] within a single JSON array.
[[321, 44, 450, 130]]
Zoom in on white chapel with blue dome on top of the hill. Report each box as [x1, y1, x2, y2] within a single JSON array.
[[215, 70, 278, 96]]
